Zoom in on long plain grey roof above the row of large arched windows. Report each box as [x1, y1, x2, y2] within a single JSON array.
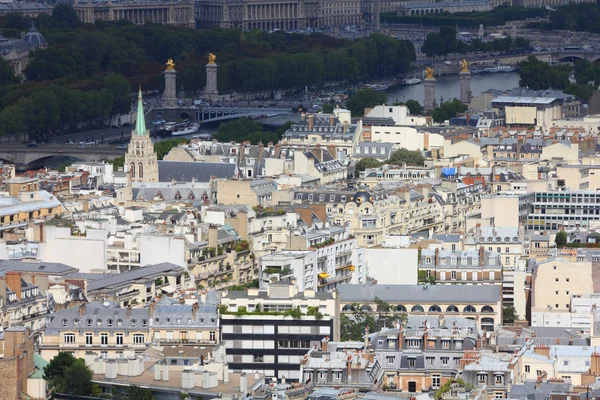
[[338, 284, 502, 304]]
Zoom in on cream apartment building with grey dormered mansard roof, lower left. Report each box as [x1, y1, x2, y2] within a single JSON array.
[[38, 301, 150, 360]]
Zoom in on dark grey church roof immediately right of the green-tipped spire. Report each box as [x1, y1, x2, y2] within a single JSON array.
[[158, 161, 238, 182]]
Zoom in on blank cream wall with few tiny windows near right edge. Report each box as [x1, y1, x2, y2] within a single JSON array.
[[532, 259, 594, 311]]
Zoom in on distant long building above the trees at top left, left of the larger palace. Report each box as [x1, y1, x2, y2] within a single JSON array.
[[73, 0, 196, 28]]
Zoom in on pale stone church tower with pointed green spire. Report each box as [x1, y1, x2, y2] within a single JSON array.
[[125, 88, 158, 182]]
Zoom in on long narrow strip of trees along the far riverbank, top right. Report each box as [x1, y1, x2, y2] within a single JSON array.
[[381, 6, 547, 28]]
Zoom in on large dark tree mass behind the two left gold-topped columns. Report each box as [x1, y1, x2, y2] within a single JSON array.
[[0, 4, 415, 138]]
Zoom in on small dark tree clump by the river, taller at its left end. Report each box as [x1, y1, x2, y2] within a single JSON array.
[[421, 26, 530, 57]]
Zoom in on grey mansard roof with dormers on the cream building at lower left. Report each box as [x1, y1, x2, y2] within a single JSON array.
[[44, 302, 150, 336]]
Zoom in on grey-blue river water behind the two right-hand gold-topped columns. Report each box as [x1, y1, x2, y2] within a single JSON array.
[[386, 72, 519, 104]]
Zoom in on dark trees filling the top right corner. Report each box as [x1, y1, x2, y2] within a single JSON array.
[[529, 2, 600, 33]]
